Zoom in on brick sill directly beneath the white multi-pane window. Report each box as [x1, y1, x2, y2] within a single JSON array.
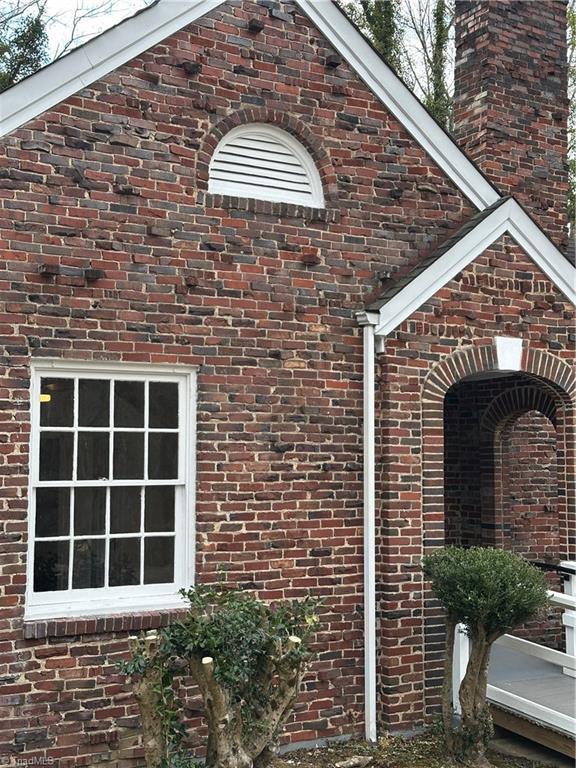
[[23, 608, 186, 640]]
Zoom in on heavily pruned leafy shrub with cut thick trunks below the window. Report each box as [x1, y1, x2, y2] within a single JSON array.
[[122, 585, 318, 768]]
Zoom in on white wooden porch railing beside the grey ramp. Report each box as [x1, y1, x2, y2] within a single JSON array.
[[452, 561, 576, 736]]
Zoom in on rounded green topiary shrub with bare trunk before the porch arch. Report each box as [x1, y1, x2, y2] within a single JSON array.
[[423, 547, 548, 766]]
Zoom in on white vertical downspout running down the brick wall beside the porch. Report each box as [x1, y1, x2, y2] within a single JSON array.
[[356, 312, 378, 741]]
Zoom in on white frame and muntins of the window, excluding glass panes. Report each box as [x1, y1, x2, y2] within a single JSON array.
[[24, 360, 197, 620]]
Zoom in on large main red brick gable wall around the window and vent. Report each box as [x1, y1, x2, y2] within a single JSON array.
[[0, 3, 470, 768]]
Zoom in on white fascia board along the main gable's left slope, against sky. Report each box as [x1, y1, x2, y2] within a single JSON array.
[[0, 0, 224, 136]]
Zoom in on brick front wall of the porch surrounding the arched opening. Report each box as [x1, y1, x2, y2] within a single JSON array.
[[378, 238, 576, 723]]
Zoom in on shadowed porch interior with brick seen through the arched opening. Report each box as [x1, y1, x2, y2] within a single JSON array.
[[444, 372, 563, 648]]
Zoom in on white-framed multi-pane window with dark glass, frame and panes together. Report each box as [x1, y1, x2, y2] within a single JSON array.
[[25, 360, 196, 619]]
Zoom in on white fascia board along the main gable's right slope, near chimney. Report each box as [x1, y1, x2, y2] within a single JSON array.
[[296, 0, 500, 211]]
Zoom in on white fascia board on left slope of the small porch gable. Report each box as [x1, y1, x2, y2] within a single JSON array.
[[375, 203, 508, 336]]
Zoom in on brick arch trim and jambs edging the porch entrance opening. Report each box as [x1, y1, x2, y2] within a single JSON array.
[[421, 344, 576, 715]]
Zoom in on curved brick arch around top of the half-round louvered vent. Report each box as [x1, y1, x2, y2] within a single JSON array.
[[196, 107, 338, 202]]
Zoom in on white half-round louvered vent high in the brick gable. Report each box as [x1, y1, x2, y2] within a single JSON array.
[[208, 123, 324, 208]]
